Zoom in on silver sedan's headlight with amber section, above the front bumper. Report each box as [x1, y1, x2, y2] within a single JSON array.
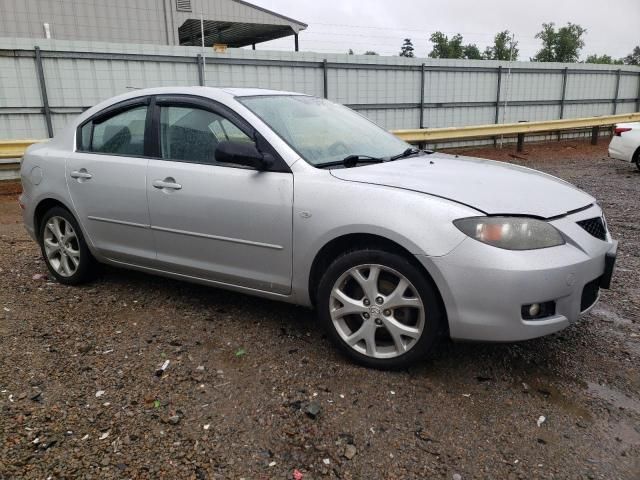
[[453, 217, 565, 250]]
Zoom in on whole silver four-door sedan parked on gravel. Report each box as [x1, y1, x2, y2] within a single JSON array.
[[20, 87, 616, 368]]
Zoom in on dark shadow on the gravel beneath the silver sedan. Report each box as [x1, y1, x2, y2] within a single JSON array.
[[92, 260, 591, 381]]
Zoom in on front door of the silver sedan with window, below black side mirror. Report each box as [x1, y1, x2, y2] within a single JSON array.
[[147, 97, 293, 294]]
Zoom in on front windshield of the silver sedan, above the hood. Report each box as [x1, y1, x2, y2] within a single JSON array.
[[236, 95, 410, 166]]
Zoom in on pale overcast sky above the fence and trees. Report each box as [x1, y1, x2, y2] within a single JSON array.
[[249, 0, 640, 60]]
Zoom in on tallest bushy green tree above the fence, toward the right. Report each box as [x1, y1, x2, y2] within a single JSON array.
[[531, 22, 587, 63]]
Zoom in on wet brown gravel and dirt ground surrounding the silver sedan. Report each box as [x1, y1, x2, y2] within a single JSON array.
[[0, 141, 640, 480]]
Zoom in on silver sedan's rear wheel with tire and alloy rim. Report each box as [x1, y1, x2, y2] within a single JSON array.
[[38, 207, 96, 285]]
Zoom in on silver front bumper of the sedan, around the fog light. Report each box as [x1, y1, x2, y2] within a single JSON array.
[[418, 207, 617, 342]]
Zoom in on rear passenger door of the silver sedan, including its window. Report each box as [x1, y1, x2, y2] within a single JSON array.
[[66, 97, 155, 265]]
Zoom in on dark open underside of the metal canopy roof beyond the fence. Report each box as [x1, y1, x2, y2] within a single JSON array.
[[178, 18, 297, 48]]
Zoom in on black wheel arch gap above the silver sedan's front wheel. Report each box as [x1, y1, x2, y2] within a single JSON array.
[[308, 233, 449, 334]]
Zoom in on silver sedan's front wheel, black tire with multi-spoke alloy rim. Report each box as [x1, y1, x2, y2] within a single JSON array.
[[316, 249, 445, 369]]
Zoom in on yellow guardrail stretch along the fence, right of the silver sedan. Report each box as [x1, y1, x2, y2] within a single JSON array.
[[392, 112, 640, 143]]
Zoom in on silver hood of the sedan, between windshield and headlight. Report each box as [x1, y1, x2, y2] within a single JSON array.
[[331, 153, 595, 218]]
